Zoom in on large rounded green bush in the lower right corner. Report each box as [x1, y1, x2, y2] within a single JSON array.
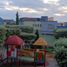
[[54, 38, 67, 67]]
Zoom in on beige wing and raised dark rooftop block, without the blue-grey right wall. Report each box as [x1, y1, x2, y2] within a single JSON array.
[[19, 16, 48, 32]]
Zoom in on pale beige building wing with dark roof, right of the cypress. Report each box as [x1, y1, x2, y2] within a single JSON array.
[[20, 18, 41, 30]]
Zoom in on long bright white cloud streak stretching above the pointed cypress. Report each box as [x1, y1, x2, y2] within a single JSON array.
[[4, 2, 48, 14]]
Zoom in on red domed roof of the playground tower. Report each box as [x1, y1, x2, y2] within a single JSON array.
[[5, 35, 24, 46]]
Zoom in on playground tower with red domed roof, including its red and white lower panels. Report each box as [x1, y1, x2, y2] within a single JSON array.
[[5, 35, 24, 63]]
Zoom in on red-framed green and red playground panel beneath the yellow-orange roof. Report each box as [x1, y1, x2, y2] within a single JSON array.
[[34, 49, 46, 67]]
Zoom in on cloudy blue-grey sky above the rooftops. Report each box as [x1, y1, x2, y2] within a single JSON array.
[[0, 0, 67, 22]]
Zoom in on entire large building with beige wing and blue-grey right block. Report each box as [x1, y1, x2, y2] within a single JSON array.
[[19, 16, 58, 34]]
